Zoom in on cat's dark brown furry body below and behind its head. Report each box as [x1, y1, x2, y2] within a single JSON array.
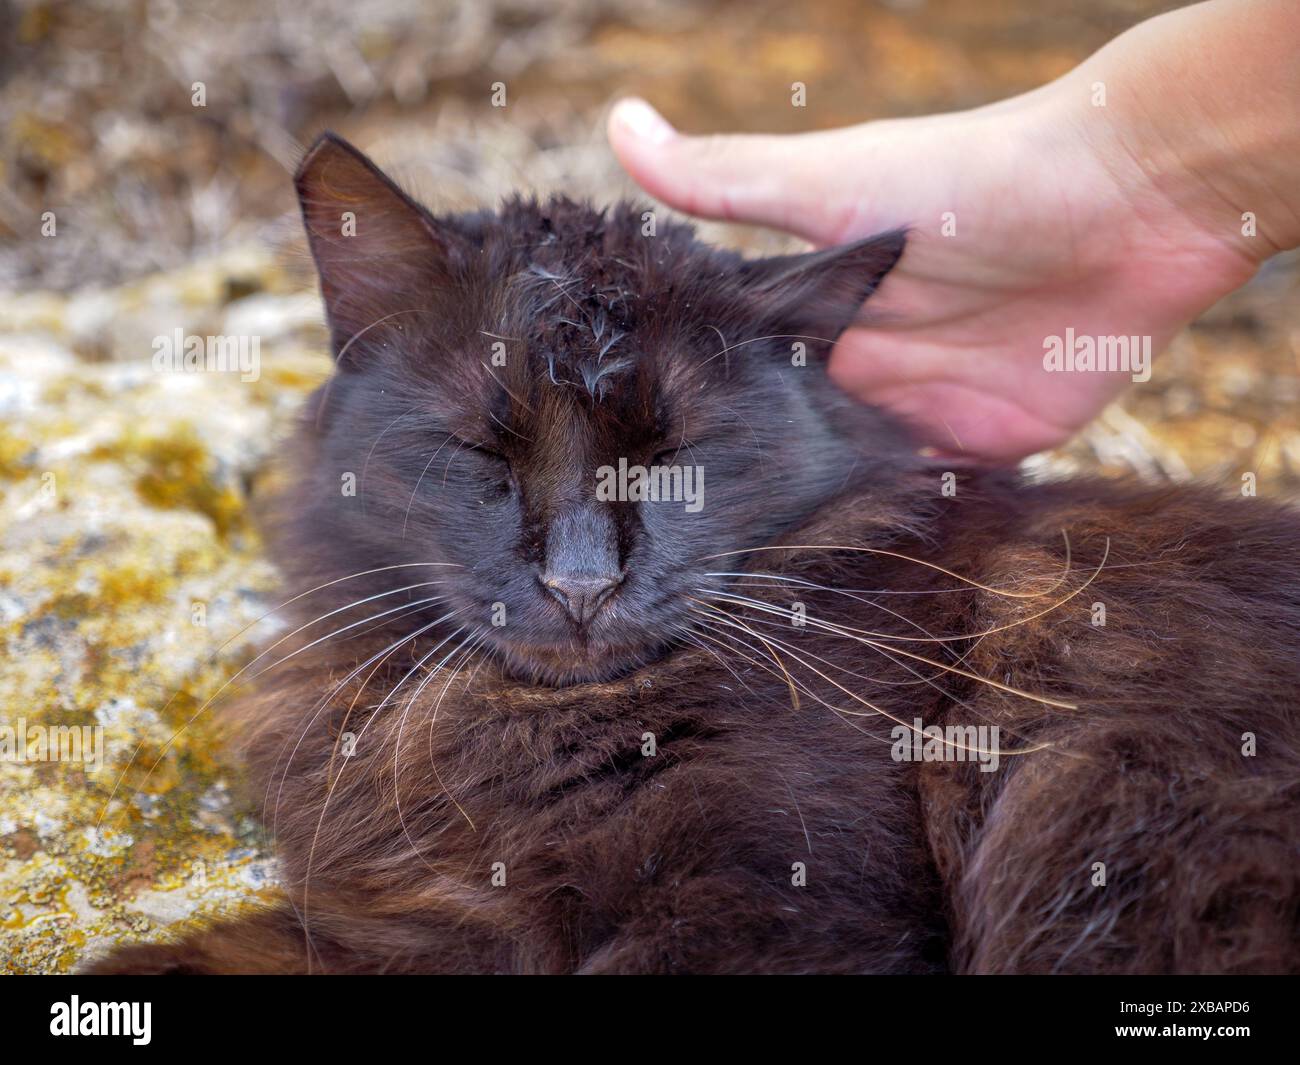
[[94, 133, 1300, 973]]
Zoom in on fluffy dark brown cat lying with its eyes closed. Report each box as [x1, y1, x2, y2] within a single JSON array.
[[94, 135, 1300, 973]]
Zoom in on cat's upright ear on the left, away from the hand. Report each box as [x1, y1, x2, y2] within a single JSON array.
[[294, 133, 455, 368]]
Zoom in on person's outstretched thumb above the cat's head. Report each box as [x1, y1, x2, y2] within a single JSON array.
[[608, 98, 855, 244]]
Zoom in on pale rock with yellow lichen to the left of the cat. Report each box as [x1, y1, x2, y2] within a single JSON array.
[[0, 248, 329, 973]]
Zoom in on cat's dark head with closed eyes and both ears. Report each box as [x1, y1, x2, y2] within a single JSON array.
[[280, 135, 904, 684]]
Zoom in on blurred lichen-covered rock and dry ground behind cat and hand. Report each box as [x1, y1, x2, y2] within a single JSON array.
[[0, 0, 1300, 971]]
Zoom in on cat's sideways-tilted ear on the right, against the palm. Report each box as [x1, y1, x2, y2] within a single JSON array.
[[740, 229, 907, 343]]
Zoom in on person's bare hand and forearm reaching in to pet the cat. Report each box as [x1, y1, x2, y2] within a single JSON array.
[[608, 0, 1300, 463]]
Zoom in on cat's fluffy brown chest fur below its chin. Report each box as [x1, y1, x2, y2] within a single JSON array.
[[250, 559, 943, 971]]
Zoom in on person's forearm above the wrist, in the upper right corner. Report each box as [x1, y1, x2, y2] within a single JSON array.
[[1044, 0, 1300, 261]]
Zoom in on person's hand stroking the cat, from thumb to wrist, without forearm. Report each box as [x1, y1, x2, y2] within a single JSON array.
[[608, 5, 1300, 462]]
